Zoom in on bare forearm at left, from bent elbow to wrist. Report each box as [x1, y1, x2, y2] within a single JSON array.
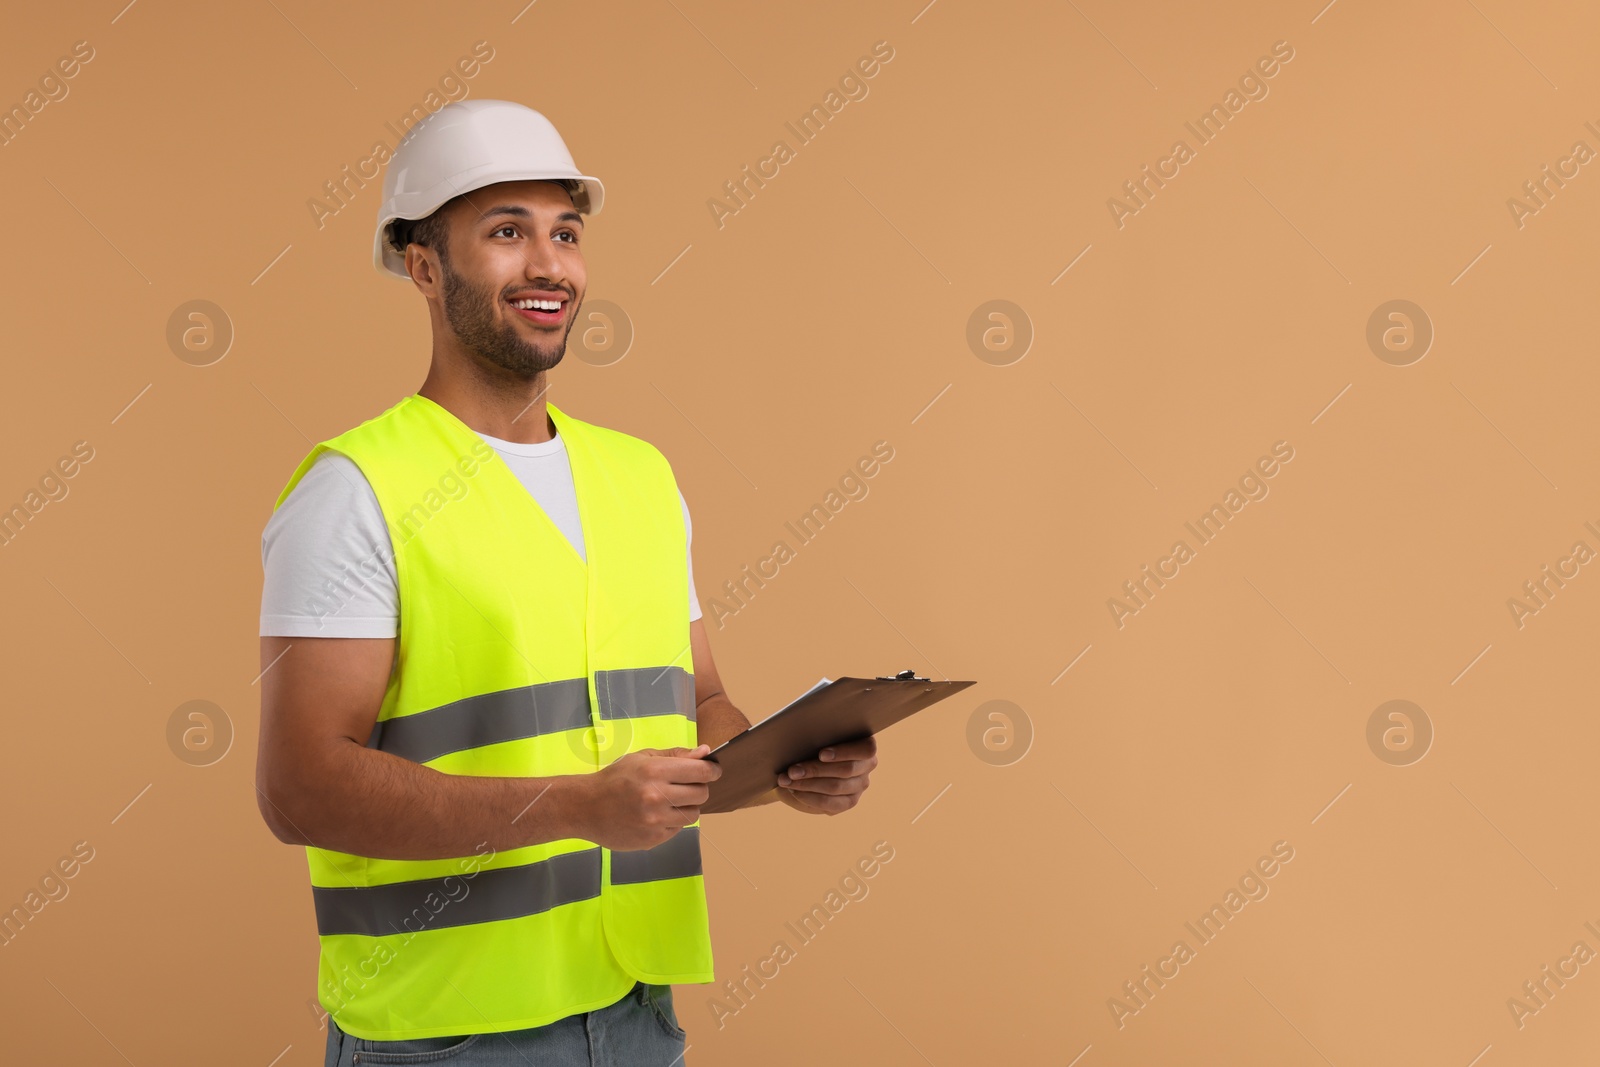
[[262, 741, 592, 859]]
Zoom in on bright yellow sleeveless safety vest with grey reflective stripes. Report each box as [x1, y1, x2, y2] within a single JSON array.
[[275, 395, 712, 1040]]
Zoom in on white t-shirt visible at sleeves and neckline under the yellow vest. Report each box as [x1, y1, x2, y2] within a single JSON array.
[[261, 434, 701, 637]]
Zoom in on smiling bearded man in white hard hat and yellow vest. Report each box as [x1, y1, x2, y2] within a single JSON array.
[[256, 101, 877, 1067]]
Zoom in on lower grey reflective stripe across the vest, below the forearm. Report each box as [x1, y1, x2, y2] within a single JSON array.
[[310, 825, 701, 937]]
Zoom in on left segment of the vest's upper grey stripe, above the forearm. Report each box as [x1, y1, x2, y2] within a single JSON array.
[[366, 681, 588, 763]]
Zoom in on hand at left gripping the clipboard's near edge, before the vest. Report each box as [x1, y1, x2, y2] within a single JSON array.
[[586, 744, 722, 853]]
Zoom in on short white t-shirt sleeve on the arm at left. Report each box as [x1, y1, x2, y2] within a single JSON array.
[[261, 451, 400, 637]]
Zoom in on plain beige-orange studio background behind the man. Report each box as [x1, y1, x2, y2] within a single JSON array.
[[0, 0, 1600, 1067]]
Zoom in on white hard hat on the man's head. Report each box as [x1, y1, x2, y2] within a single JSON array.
[[373, 101, 605, 280]]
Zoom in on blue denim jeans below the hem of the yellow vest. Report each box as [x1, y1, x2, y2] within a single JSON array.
[[323, 982, 685, 1067]]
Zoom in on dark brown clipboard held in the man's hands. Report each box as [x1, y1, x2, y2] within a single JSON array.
[[699, 670, 978, 814]]
